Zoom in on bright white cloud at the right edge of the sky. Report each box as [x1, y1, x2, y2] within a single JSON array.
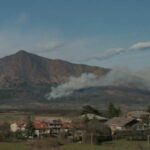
[[130, 41, 150, 50]]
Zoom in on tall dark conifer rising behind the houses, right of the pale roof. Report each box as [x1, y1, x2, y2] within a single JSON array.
[[107, 103, 121, 118]]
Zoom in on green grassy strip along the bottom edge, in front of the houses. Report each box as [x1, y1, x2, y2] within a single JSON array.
[[0, 140, 148, 150]]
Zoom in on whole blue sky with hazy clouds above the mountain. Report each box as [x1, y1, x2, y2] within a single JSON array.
[[0, 0, 150, 70]]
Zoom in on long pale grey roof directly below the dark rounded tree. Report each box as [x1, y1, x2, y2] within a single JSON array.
[[80, 113, 108, 122]]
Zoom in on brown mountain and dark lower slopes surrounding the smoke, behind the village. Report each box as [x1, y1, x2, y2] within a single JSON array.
[[0, 50, 150, 109]]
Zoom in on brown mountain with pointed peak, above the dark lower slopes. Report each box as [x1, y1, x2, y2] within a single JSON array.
[[0, 50, 109, 87]]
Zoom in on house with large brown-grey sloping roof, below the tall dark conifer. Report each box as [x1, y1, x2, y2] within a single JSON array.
[[105, 117, 138, 135]]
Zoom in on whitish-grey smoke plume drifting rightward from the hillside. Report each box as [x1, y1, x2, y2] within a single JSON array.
[[47, 70, 150, 100]]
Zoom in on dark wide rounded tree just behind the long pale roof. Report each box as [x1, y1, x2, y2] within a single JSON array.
[[81, 105, 100, 115]]
